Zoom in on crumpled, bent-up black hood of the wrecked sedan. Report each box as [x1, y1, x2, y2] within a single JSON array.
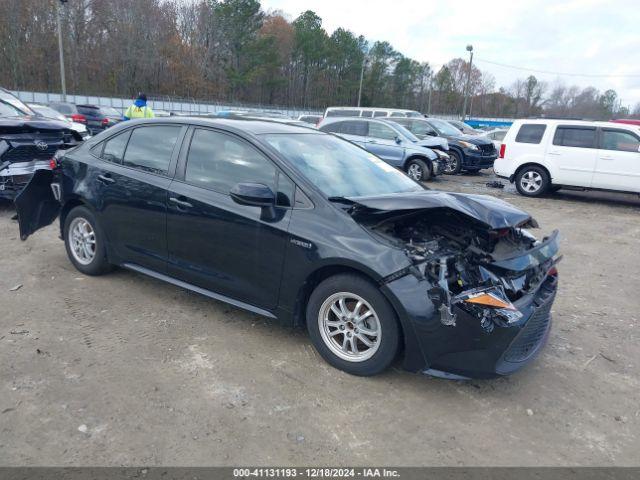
[[347, 190, 538, 229]]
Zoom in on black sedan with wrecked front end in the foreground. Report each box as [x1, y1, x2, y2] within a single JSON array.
[[16, 118, 558, 378]]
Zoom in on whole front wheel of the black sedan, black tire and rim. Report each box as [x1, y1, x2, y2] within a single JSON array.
[[306, 274, 400, 376]]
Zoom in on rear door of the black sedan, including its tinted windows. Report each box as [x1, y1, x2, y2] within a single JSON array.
[[94, 124, 187, 273]]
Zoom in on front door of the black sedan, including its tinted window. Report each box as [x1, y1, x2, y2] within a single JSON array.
[[167, 128, 294, 309]]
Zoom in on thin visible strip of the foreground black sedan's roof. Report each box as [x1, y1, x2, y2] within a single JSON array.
[[111, 116, 324, 135]]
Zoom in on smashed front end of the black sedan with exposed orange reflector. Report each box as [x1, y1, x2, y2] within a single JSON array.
[[350, 191, 560, 376]]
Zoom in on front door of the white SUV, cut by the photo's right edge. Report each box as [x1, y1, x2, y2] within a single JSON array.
[[592, 128, 640, 192]]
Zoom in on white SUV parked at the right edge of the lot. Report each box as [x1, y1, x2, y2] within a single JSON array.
[[493, 120, 640, 197]]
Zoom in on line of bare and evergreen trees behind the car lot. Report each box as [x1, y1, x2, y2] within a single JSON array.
[[0, 0, 640, 118]]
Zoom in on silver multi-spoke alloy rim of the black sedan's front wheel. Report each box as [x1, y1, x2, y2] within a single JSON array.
[[318, 292, 382, 362]]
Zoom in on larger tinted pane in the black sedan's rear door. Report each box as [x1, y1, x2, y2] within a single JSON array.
[[122, 125, 181, 175]]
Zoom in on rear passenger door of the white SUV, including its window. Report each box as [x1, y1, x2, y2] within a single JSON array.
[[546, 125, 598, 187]]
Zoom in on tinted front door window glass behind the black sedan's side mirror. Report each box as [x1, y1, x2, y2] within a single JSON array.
[[185, 129, 276, 195]]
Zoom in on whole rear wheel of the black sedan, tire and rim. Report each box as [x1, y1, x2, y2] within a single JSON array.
[[63, 207, 112, 275]]
